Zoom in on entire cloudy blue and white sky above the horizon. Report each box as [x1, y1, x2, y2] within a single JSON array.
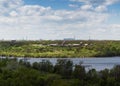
[[0, 0, 120, 40]]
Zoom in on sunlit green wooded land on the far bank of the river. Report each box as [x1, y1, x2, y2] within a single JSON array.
[[0, 40, 120, 58]]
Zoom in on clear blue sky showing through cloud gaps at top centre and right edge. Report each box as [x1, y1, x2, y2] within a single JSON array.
[[24, 0, 120, 12]]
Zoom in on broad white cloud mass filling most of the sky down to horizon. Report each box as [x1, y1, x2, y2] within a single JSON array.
[[0, 0, 120, 39]]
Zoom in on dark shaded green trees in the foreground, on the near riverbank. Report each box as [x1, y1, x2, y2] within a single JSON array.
[[0, 58, 120, 86]]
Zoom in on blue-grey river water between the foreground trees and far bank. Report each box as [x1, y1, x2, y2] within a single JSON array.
[[19, 57, 120, 71]]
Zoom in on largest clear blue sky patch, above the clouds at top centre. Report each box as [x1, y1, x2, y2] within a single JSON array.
[[24, 0, 78, 10]]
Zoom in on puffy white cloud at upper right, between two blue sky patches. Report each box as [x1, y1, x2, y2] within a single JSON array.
[[70, 0, 120, 12]]
